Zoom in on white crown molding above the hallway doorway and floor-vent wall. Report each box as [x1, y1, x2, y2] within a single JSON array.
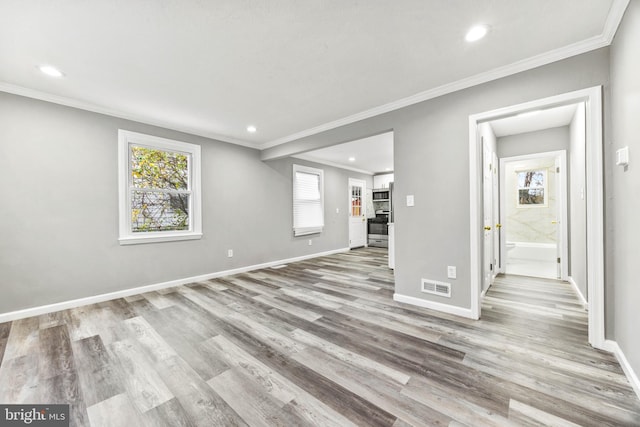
[[260, 0, 630, 150]]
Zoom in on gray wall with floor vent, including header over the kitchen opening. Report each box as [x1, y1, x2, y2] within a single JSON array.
[[263, 48, 609, 308]]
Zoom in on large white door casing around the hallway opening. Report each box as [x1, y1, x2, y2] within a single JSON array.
[[469, 86, 605, 350]]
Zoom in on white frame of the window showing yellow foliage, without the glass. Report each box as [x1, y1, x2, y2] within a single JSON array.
[[118, 129, 202, 245]]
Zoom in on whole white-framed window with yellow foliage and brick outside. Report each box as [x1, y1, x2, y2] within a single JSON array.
[[118, 130, 202, 245]]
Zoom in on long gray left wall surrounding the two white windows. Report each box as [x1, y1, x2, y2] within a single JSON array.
[[0, 92, 373, 313]]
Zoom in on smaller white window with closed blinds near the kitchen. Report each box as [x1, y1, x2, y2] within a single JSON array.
[[293, 165, 324, 236]]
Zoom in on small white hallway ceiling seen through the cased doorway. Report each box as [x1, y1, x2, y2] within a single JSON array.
[[490, 104, 577, 138]]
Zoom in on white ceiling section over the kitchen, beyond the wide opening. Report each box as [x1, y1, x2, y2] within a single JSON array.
[[294, 132, 393, 175]]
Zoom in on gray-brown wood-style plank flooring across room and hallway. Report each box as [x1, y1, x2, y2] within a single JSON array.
[[0, 248, 640, 427]]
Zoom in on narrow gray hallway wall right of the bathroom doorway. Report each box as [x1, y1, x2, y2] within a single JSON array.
[[569, 103, 589, 299]]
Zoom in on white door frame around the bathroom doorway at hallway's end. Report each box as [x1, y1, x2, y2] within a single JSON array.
[[500, 150, 569, 280]]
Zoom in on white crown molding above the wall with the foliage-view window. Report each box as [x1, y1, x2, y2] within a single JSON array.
[[0, 82, 261, 150]]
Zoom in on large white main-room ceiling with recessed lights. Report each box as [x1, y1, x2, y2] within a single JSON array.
[[0, 0, 628, 148]]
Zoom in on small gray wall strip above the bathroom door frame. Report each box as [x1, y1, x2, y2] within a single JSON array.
[[498, 126, 570, 159]]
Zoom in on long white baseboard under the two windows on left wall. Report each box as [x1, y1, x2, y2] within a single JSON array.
[[0, 248, 349, 323]]
